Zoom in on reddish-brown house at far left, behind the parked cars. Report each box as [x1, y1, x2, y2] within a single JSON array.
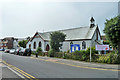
[[0, 37, 18, 49]]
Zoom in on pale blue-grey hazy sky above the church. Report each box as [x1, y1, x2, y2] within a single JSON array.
[[0, 0, 118, 38]]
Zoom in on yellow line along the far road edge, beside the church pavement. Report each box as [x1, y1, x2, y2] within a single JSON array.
[[31, 57, 120, 71]]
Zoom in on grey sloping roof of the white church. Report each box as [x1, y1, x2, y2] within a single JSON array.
[[39, 26, 97, 40]]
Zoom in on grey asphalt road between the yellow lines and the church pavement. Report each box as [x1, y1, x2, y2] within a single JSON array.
[[0, 53, 118, 78]]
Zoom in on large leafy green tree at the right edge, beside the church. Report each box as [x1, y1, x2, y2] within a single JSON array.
[[104, 16, 120, 54]]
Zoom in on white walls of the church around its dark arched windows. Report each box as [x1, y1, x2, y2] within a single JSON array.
[[26, 28, 101, 52]]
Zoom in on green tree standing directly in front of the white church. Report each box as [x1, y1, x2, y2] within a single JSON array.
[[50, 31, 66, 52]]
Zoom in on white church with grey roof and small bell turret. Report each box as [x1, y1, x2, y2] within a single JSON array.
[[26, 17, 101, 52]]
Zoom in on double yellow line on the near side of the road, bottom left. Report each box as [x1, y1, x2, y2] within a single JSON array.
[[2, 61, 38, 80]]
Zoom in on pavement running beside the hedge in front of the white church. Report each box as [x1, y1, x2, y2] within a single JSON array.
[[32, 55, 120, 70]]
